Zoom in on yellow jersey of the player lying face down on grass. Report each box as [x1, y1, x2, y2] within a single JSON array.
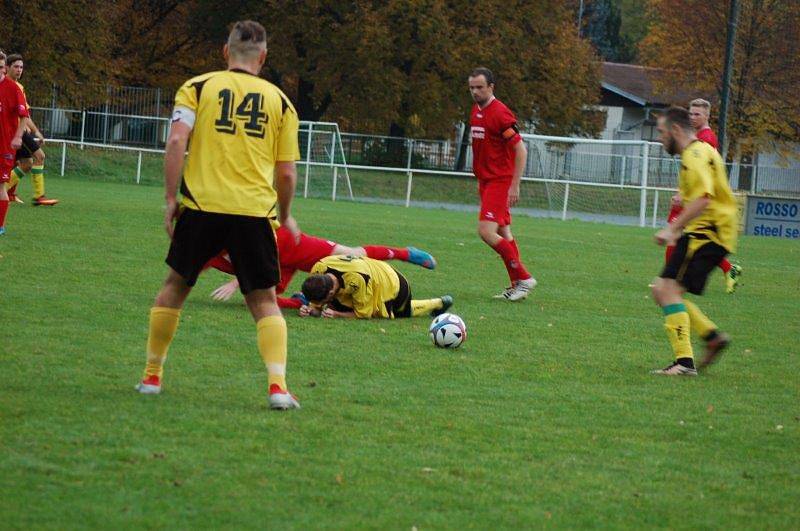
[[311, 256, 400, 319]]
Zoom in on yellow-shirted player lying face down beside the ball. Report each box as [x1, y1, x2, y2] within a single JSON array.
[[300, 255, 453, 319]]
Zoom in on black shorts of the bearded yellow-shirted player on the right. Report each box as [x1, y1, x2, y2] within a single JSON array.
[[660, 234, 728, 295]]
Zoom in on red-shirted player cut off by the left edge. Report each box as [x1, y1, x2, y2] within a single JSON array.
[[0, 52, 28, 235]]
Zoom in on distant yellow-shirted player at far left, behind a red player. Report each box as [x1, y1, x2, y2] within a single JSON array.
[[7, 54, 58, 206]]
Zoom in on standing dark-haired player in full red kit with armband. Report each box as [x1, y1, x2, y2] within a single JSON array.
[[469, 68, 536, 301]]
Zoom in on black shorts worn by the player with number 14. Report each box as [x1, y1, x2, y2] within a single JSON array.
[[166, 208, 280, 295]]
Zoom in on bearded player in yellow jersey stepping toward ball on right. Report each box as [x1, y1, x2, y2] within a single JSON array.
[[653, 107, 738, 376]]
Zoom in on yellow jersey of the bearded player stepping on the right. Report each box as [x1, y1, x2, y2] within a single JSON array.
[[678, 140, 739, 253]]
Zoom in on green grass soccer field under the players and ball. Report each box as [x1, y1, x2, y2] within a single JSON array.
[[0, 172, 800, 529]]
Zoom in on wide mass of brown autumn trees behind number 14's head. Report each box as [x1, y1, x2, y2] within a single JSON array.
[[0, 0, 602, 137]]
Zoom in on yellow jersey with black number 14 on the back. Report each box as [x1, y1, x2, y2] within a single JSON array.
[[173, 70, 300, 217]]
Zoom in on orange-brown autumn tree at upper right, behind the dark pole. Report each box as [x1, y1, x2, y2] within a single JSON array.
[[639, 0, 800, 157]]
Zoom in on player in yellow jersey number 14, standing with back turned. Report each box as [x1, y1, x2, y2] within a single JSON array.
[[137, 21, 300, 409]]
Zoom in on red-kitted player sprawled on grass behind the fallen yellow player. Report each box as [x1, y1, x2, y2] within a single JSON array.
[[206, 227, 436, 308]]
